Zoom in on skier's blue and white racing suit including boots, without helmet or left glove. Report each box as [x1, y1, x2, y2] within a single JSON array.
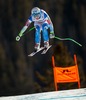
[[19, 9, 54, 49]]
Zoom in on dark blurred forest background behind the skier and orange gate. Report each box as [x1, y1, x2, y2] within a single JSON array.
[[0, 0, 86, 96]]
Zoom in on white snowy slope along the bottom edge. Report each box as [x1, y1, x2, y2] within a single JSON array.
[[0, 88, 86, 100]]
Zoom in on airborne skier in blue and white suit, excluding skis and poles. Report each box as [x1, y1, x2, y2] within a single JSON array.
[[16, 7, 55, 52]]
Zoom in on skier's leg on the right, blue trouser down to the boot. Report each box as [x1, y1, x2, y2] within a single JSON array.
[[42, 23, 49, 48]]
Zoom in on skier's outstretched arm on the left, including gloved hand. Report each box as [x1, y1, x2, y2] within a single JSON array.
[[16, 17, 32, 41]]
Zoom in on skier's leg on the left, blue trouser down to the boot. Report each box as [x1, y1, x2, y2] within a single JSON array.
[[35, 25, 41, 50]]
